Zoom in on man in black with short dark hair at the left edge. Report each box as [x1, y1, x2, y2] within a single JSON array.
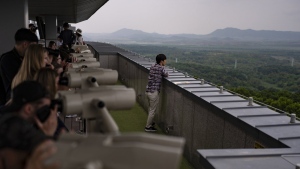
[[0, 28, 38, 106]]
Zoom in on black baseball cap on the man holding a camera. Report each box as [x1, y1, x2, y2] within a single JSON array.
[[0, 81, 50, 113]]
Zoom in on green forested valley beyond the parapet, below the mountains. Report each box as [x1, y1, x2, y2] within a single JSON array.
[[118, 43, 300, 117]]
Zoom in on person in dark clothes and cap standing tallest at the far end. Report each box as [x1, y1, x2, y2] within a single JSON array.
[[58, 22, 76, 49]]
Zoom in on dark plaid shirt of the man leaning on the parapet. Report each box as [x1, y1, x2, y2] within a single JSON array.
[[146, 63, 168, 93]]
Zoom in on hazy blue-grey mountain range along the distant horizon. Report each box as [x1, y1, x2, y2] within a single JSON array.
[[84, 28, 300, 44]]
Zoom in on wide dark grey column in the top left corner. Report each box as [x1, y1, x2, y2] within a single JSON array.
[[0, 0, 29, 55]]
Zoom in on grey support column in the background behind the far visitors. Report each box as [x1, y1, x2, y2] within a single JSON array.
[[45, 15, 57, 46]]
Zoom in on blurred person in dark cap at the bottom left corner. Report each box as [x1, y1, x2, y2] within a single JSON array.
[[0, 114, 58, 169]]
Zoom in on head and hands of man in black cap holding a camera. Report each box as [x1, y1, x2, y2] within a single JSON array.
[[0, 81, 57, 136]]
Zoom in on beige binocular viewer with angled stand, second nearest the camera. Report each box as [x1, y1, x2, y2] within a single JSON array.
[[58, 86, 136, 134]]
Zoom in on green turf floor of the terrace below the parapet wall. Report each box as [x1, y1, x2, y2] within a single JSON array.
[[110, 104, 193, 169]]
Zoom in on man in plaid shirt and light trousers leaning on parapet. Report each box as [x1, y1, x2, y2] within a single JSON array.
[[145, 54, 168, 131]]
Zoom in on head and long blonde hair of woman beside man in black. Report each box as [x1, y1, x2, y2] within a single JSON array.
[[11, 44, 48, 89]]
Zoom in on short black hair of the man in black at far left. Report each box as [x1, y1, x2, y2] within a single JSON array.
[[15, 28, 39, 43]]
